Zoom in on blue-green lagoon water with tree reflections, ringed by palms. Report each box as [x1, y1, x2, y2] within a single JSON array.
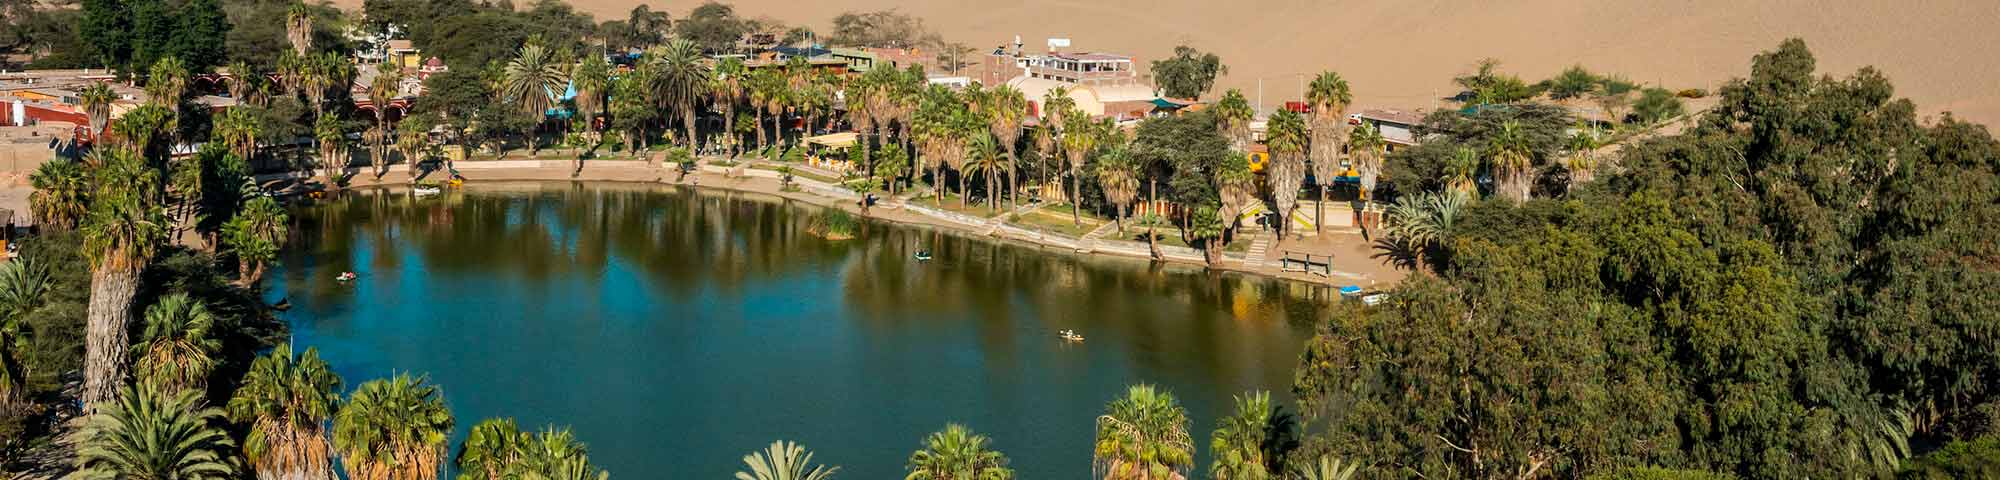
[[270, 184, 1332, 478]]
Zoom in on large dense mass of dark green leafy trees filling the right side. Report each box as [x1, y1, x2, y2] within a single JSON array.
[[1294, 40, 2000, 478]]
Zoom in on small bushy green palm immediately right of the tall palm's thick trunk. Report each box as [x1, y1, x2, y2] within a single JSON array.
[[132, 294, 222, 394]]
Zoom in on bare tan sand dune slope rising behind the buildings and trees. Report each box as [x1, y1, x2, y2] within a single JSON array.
[[342, 0, 2000, 124]]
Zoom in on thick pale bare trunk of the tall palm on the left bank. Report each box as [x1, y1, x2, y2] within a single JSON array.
[[84, 268, 138, 410]]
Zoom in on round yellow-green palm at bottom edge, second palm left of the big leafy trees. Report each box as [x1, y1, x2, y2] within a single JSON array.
[[1092, 384, 1194, 480]]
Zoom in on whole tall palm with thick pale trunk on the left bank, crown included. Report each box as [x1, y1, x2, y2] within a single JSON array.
[[82, 148, 166, 410]]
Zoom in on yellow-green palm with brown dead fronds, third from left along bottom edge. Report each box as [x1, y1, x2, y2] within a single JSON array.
[[334, 374, 452, 480]]
